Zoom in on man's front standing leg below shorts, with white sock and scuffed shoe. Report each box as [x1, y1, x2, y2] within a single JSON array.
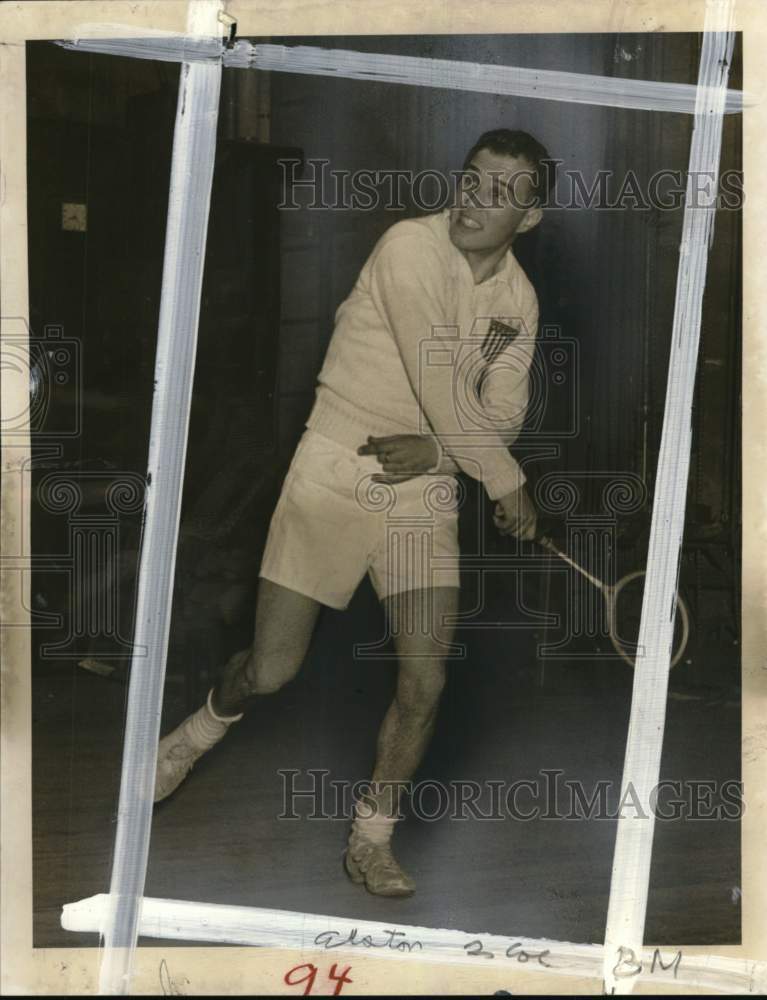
[[346, 587, 458, 896]]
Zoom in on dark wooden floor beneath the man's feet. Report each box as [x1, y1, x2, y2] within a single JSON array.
[[33, 576, 740, 947]]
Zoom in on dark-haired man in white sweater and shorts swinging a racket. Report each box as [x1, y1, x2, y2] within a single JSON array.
[[155, 129, 552, 896]]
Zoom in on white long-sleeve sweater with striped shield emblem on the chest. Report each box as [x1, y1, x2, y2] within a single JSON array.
[[307, 209, 538, 499]]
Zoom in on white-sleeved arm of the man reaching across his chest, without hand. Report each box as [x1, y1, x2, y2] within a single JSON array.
[[371, 235, 525, 500]]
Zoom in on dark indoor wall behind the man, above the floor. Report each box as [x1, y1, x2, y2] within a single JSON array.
[[28, 34, 741, 697]]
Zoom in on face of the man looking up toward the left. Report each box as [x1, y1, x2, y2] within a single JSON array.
[[450, 149, 541, 253]]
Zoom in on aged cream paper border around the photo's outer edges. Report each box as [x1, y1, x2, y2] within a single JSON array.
[[0, 2, 767, 993]]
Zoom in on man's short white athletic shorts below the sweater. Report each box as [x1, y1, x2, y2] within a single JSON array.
[[259, 430, 459, 609]]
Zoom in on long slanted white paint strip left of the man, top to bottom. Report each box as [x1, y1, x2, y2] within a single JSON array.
[[99, 0, 222, 996]]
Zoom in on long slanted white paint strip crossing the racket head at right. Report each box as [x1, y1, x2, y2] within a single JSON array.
[[604, 0, 735, 994]]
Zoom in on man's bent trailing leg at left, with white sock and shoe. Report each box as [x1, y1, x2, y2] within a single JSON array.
[[155, 578, 321, 802]]
